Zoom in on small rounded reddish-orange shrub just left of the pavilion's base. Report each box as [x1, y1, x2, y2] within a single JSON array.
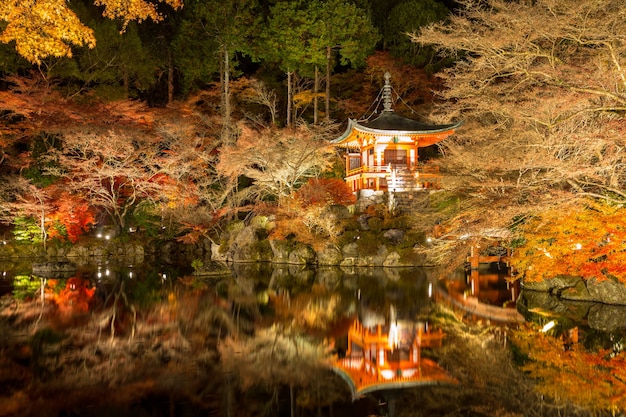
[[296, 178, 356, 207]]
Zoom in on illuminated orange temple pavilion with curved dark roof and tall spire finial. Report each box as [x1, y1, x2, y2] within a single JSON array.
[[331, 73, 462, 192]]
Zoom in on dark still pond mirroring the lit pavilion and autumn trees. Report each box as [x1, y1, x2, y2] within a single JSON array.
[[0, 260, 624, 416]]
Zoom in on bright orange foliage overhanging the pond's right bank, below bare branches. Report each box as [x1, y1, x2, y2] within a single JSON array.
[[512, 198, 626, 282]]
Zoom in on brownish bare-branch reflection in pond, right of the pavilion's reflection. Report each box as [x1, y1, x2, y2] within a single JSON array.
[[397, 306, 598, 417]]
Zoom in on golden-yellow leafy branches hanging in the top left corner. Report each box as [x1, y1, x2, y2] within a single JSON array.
[[0, 0, 182, 64]]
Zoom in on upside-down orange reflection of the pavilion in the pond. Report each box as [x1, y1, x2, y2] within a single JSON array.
[[334, 310, 456, 399]]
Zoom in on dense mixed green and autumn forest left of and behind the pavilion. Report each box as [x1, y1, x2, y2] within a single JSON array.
[[0, 0, 450, 247]]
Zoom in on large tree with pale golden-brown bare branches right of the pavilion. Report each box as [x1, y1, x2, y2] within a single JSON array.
[[413, 0, 626, 257]]
